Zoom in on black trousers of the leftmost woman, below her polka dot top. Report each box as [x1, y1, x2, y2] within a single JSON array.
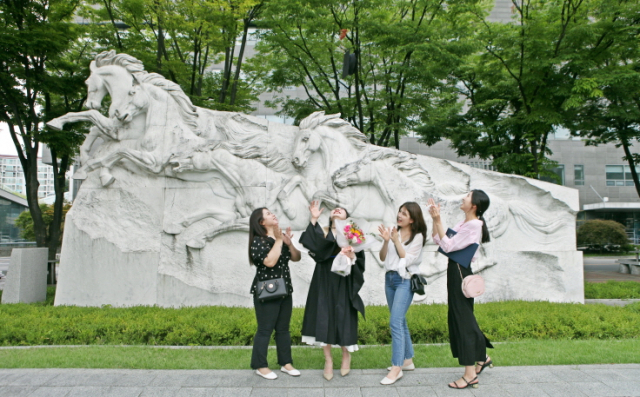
[[251, 295, 293, 369]]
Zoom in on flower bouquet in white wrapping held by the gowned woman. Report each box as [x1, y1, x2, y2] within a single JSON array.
[[331, 218, 377, 277]]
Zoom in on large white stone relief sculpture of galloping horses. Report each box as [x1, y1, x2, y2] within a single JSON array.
[[53, 51, 583, 307]]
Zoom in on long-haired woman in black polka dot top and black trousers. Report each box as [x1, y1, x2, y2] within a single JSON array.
[[249, 208, 300, 380]]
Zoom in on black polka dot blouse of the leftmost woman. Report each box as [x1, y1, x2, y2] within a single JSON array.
[[251, 236, 293, 295]]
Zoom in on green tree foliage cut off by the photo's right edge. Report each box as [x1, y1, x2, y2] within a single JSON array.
[[567, 0, 640, 196]]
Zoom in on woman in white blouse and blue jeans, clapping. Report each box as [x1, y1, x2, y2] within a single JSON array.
[[378, 202, 427, 385]]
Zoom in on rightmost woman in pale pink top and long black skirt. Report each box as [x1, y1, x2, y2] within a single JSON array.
[[429, 190, 493, 389]]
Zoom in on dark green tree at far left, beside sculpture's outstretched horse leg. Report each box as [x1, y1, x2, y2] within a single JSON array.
[[0, 0, 86, 257]]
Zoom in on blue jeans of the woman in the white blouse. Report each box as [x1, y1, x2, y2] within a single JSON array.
[[384, 272, 413, 367]]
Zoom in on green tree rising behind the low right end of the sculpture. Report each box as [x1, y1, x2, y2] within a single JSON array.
[[419, 0, 607, 178]]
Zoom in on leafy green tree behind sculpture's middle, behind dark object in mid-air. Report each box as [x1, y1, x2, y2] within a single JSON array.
[[246, 0, 486, 147]]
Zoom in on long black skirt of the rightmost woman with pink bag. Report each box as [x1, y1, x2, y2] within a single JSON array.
[[447, 259, 493, 366]]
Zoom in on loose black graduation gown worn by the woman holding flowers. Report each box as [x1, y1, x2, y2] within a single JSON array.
[[300, 223, 364, 346]]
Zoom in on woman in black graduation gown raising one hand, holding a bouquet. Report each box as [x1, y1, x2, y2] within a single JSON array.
[[300, 201, 364, 380]]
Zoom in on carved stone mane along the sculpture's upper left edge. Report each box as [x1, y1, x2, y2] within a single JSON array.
[[95, 50, 198, 134]]
